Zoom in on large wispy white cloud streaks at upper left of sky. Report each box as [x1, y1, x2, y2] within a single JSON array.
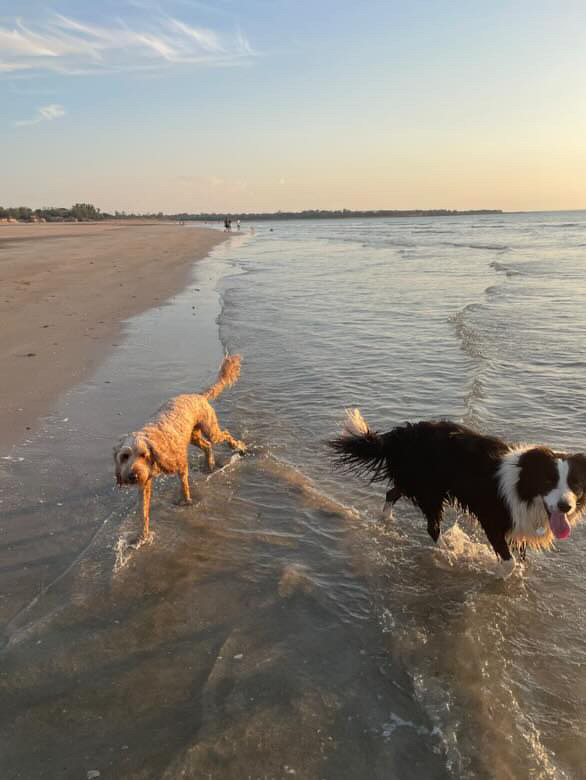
[[0, 13, 255, 76]]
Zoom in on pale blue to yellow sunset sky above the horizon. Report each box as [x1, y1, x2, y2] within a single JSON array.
[[0, 0, 586, 213]]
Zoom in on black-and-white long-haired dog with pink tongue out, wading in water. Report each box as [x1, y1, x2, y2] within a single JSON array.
[[330, 409, 586, 577]]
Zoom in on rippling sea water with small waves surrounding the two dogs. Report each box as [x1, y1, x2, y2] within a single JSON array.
[[0, 212, 586, 779]]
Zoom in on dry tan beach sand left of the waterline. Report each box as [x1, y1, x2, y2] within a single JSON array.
[[0, 223, 225, 451]]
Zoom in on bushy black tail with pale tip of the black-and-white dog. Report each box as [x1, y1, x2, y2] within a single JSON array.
[[329, 409, 388, 482]]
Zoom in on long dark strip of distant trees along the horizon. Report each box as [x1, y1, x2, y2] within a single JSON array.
[[0, 203, 502, 222]]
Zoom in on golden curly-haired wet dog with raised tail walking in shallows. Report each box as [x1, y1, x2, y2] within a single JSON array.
[[114, 355, 246, 542]]
